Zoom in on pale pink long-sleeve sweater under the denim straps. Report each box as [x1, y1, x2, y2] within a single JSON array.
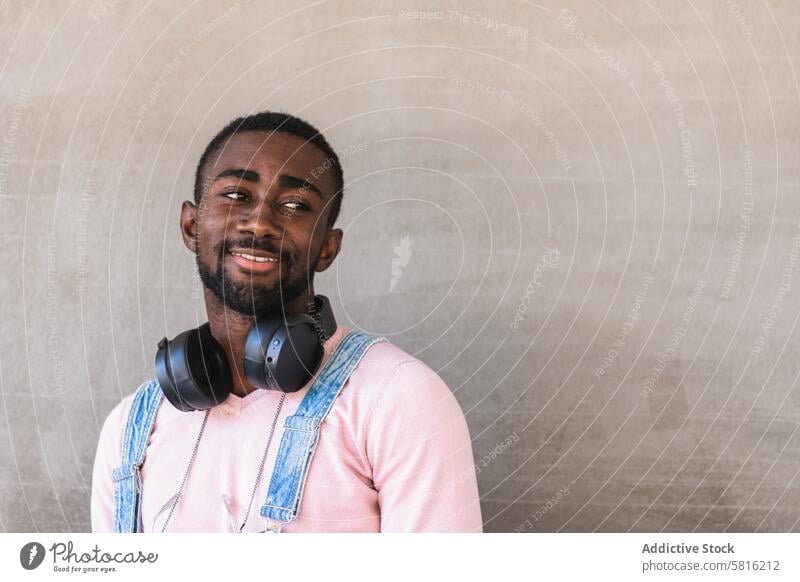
[[91, 326, 482, 532]]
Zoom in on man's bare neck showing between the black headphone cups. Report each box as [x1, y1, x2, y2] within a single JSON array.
[[203, 289, 314, 397]]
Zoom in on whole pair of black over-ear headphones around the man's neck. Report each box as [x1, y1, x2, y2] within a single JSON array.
[[156, 295, 336, 412]]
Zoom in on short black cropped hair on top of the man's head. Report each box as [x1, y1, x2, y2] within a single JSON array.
[[194, 111, 344, 228]]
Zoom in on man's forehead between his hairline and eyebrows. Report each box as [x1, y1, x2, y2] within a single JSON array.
[[205, 131, 336, 195]]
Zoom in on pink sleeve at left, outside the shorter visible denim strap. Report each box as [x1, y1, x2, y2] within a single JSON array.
[[91, 397, 131, 533]]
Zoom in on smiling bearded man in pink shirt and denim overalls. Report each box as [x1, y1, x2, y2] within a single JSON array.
[[91, 112, 482, 532]]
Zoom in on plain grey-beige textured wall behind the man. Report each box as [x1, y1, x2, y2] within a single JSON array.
[[0, 0, 800, 531]]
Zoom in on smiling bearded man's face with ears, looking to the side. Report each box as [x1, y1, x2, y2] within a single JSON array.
[[181, 132, 342, 317]]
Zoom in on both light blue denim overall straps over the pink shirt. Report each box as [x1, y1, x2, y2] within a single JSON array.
[[112, 332, 386, 533]]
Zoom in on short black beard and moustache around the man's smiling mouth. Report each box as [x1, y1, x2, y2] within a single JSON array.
[[195, 239, 316, 317]]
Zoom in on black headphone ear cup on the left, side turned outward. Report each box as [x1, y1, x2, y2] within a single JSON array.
[[156, 323, 231, 412]]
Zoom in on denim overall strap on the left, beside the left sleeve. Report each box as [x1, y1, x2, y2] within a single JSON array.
[[111, 380, 164, 533]]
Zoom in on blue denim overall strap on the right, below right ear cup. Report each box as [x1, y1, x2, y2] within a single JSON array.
[[261, 332, 386, 531]]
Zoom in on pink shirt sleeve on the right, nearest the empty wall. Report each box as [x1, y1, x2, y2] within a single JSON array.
[[365, 359, 482, 532]]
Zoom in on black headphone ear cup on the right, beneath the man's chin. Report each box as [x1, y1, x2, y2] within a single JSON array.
[[244, 314, 325, 392]]
